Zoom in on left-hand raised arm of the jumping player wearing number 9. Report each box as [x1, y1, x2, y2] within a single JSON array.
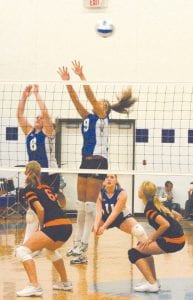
[[57, 67, 89, 119]]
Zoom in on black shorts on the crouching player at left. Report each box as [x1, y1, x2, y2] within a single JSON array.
[[41, 224, 72, 242]]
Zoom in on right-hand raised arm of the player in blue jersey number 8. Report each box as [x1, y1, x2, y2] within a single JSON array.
[[33, 84, 55, 136]]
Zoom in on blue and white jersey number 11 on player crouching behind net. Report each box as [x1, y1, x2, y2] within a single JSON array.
[[101, 188, 129, 218]]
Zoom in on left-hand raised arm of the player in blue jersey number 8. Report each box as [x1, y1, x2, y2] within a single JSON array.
[[17, 85, 33, 136]]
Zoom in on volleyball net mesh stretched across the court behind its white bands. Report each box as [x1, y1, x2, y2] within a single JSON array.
[[0, 82, 193, 211]]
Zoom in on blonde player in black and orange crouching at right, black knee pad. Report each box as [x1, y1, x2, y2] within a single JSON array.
[[128, 181, 185, 293]]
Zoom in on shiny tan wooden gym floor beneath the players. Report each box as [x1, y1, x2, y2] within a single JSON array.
[[0, 217, 193, 300]]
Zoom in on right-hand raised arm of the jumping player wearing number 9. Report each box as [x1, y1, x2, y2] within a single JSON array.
[[72, 60, 100, 113]]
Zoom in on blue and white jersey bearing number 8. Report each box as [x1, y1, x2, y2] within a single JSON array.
[[26, 129, 57, 168]]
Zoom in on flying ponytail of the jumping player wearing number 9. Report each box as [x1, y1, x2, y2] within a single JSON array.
[[105, 88, 137, 114]]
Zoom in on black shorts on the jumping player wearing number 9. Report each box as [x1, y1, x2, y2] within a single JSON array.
[[78, 156, 108, 180]]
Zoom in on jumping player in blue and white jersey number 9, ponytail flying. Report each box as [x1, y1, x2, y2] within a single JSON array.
[[58, 61, 136, 264]]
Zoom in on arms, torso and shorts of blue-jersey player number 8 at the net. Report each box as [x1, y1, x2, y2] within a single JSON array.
[[17, 84, 60, 193]]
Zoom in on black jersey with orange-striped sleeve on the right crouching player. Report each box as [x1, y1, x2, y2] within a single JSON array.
[[144, 201, 184, 239]]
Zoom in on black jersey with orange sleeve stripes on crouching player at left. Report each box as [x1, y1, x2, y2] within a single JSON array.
[[25, 184, 66, 224]]
